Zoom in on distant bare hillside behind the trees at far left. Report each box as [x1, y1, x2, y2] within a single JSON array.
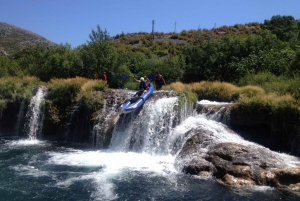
[[0, 22, 56, 54]]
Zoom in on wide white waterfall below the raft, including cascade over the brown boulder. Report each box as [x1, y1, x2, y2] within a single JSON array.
[[109, 97, 294, 169]]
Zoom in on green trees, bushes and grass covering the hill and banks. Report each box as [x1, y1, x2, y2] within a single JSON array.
[[0, 16, 300, 141]]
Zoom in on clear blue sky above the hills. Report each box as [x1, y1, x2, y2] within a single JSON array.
[[0, 0, 300, 48]]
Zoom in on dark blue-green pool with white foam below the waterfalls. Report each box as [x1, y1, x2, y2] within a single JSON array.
[[0, 139, 300, 201]]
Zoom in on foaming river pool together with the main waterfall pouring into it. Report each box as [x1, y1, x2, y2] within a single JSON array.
[[0, 96, 299, 201]]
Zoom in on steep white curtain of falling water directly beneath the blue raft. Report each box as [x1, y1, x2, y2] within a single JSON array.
[[110, 97, 177, 154]]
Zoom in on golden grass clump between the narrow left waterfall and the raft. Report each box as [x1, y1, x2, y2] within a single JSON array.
[[46, 77, 107, 125]]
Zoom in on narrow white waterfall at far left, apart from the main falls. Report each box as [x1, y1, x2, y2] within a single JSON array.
[[24, 87, 46, 140]]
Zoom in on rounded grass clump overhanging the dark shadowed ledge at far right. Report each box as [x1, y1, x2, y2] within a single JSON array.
[[231, 94, 300, 142]]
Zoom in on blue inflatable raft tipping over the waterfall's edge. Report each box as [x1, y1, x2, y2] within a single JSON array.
[[120, 83, 154, 114]]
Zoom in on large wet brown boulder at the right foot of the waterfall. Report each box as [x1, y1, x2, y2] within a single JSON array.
[[176, 129, 300, 190]]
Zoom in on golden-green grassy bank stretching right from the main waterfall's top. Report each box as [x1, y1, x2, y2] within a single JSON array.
[[164, 79, 300, 143]]
